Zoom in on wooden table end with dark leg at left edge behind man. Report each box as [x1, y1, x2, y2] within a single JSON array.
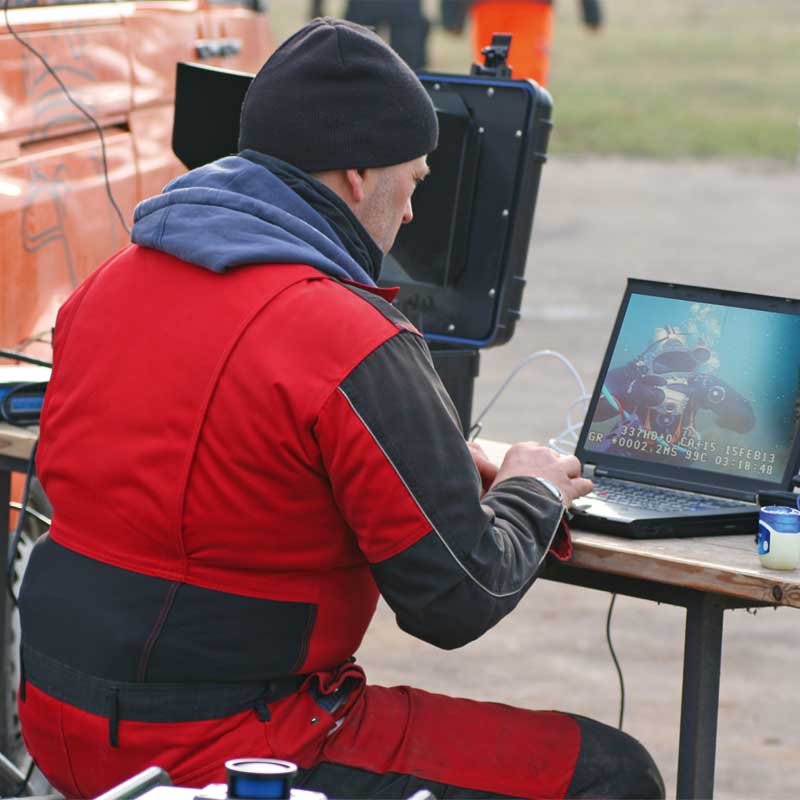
[[0, 423, 39, 753]]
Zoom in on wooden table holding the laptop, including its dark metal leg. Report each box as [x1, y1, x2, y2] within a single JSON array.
[[479, 440, 800, 800]]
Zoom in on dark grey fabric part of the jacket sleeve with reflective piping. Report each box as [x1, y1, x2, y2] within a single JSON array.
[[339, 332, 563, 647]]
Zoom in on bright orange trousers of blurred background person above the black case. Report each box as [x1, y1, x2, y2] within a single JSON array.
[[471, 0, 553, 86]]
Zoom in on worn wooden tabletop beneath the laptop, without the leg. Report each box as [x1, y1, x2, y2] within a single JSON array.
[[478, 439, 800, 608]]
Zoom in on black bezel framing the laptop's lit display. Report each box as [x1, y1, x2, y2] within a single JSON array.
[[575, 278, 800, 498]]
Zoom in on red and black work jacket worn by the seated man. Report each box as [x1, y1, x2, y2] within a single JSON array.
[[20, 153, 568, 780]]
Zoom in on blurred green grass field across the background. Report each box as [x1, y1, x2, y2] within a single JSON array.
[[271, 0, 800, 161]]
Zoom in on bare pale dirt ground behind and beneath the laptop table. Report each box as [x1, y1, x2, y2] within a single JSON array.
[[358, 159, 800, 800]]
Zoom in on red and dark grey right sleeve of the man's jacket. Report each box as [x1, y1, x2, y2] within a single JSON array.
[[315, 330, 563, 649]]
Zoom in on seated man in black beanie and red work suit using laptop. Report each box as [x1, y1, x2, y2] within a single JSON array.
[[15, 19, 662, 798]]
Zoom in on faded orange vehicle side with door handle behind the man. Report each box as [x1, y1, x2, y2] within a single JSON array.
[[0, 0, 274, 359]]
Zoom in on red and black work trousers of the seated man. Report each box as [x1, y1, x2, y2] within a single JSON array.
[[19, 649, 664, 798]]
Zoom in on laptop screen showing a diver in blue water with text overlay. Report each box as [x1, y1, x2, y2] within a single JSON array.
[[581, 281, 800, 488]]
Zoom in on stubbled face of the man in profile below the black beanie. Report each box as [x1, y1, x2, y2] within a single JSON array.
[[356, 156, 430, 253]]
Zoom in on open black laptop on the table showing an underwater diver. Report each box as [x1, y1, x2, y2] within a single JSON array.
[[572, 279, 800, 538]]
